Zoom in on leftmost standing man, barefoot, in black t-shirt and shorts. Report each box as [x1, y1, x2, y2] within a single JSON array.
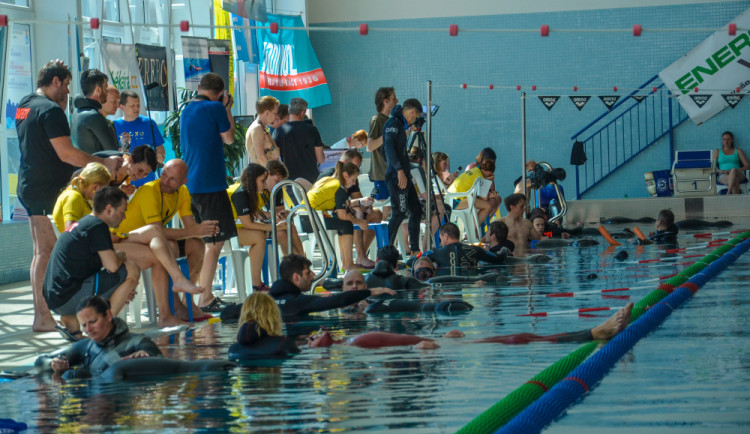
[[16, 60, 122, 332]]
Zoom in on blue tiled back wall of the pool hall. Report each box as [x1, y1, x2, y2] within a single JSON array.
[[310, 2, 750, 199]]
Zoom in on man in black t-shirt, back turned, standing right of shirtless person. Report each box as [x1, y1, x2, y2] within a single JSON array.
[[273, 98, 326, 184]]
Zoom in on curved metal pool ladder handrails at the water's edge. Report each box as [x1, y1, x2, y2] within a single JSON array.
[[268, 179, 336, 290]]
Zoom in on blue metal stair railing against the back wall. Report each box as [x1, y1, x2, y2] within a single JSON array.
[[571, 75, 688, 199]]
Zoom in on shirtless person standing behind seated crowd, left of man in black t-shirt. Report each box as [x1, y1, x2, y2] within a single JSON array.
[[245, 96, 280, 166]]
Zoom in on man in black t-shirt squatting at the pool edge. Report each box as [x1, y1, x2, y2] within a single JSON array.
[[43, 187, 141, 339]]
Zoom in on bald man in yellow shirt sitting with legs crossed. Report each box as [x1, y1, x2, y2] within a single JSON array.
[[112, 159, 218, 327]]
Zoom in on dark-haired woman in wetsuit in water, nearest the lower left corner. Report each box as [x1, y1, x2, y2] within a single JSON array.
[[36, 296, 162, 376]]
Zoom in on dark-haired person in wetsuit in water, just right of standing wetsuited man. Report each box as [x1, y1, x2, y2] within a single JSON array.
[[424, 223, 509, 274]]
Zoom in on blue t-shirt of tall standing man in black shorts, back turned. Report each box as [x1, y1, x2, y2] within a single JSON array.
[[180, 100, 231, 194]]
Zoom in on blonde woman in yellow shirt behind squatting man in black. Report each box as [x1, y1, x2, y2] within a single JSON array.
[[52, 163, 110, 233]]
